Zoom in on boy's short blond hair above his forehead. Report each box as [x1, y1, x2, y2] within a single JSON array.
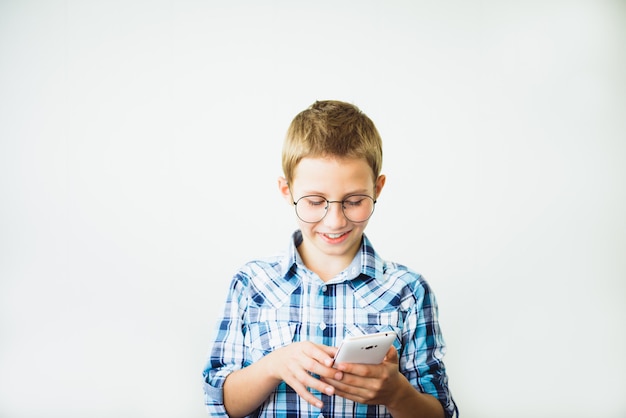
[[282, 100, 383, 182]]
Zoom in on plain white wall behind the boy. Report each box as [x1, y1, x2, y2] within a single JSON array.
[[0, 0, 626, 418]]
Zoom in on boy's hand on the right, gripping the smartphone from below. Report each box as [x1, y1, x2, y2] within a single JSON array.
[[322, 346, 404, 405]]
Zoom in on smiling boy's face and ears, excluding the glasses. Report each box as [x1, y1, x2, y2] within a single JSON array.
[[279, 157, 385, 273]]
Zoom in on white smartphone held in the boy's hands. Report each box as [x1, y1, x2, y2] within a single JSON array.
[[333, 331, 396, 364]]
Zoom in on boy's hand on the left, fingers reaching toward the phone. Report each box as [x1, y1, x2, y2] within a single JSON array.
[[266, 341, 343, 408]]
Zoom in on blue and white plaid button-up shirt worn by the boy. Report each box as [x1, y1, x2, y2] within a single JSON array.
[[204, 231, 458, 418]]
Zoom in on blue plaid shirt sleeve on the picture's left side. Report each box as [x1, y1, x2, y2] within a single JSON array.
[[203, 274, 249, 417]]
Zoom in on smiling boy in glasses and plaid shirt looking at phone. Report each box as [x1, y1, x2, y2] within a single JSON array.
[[204, 101, 458, 418]]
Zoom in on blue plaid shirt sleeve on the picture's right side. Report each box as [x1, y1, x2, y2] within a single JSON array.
[[400, 276, 458, 418]]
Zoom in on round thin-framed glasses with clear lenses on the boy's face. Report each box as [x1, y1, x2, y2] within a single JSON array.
[[293, 194, 376, 223]]
